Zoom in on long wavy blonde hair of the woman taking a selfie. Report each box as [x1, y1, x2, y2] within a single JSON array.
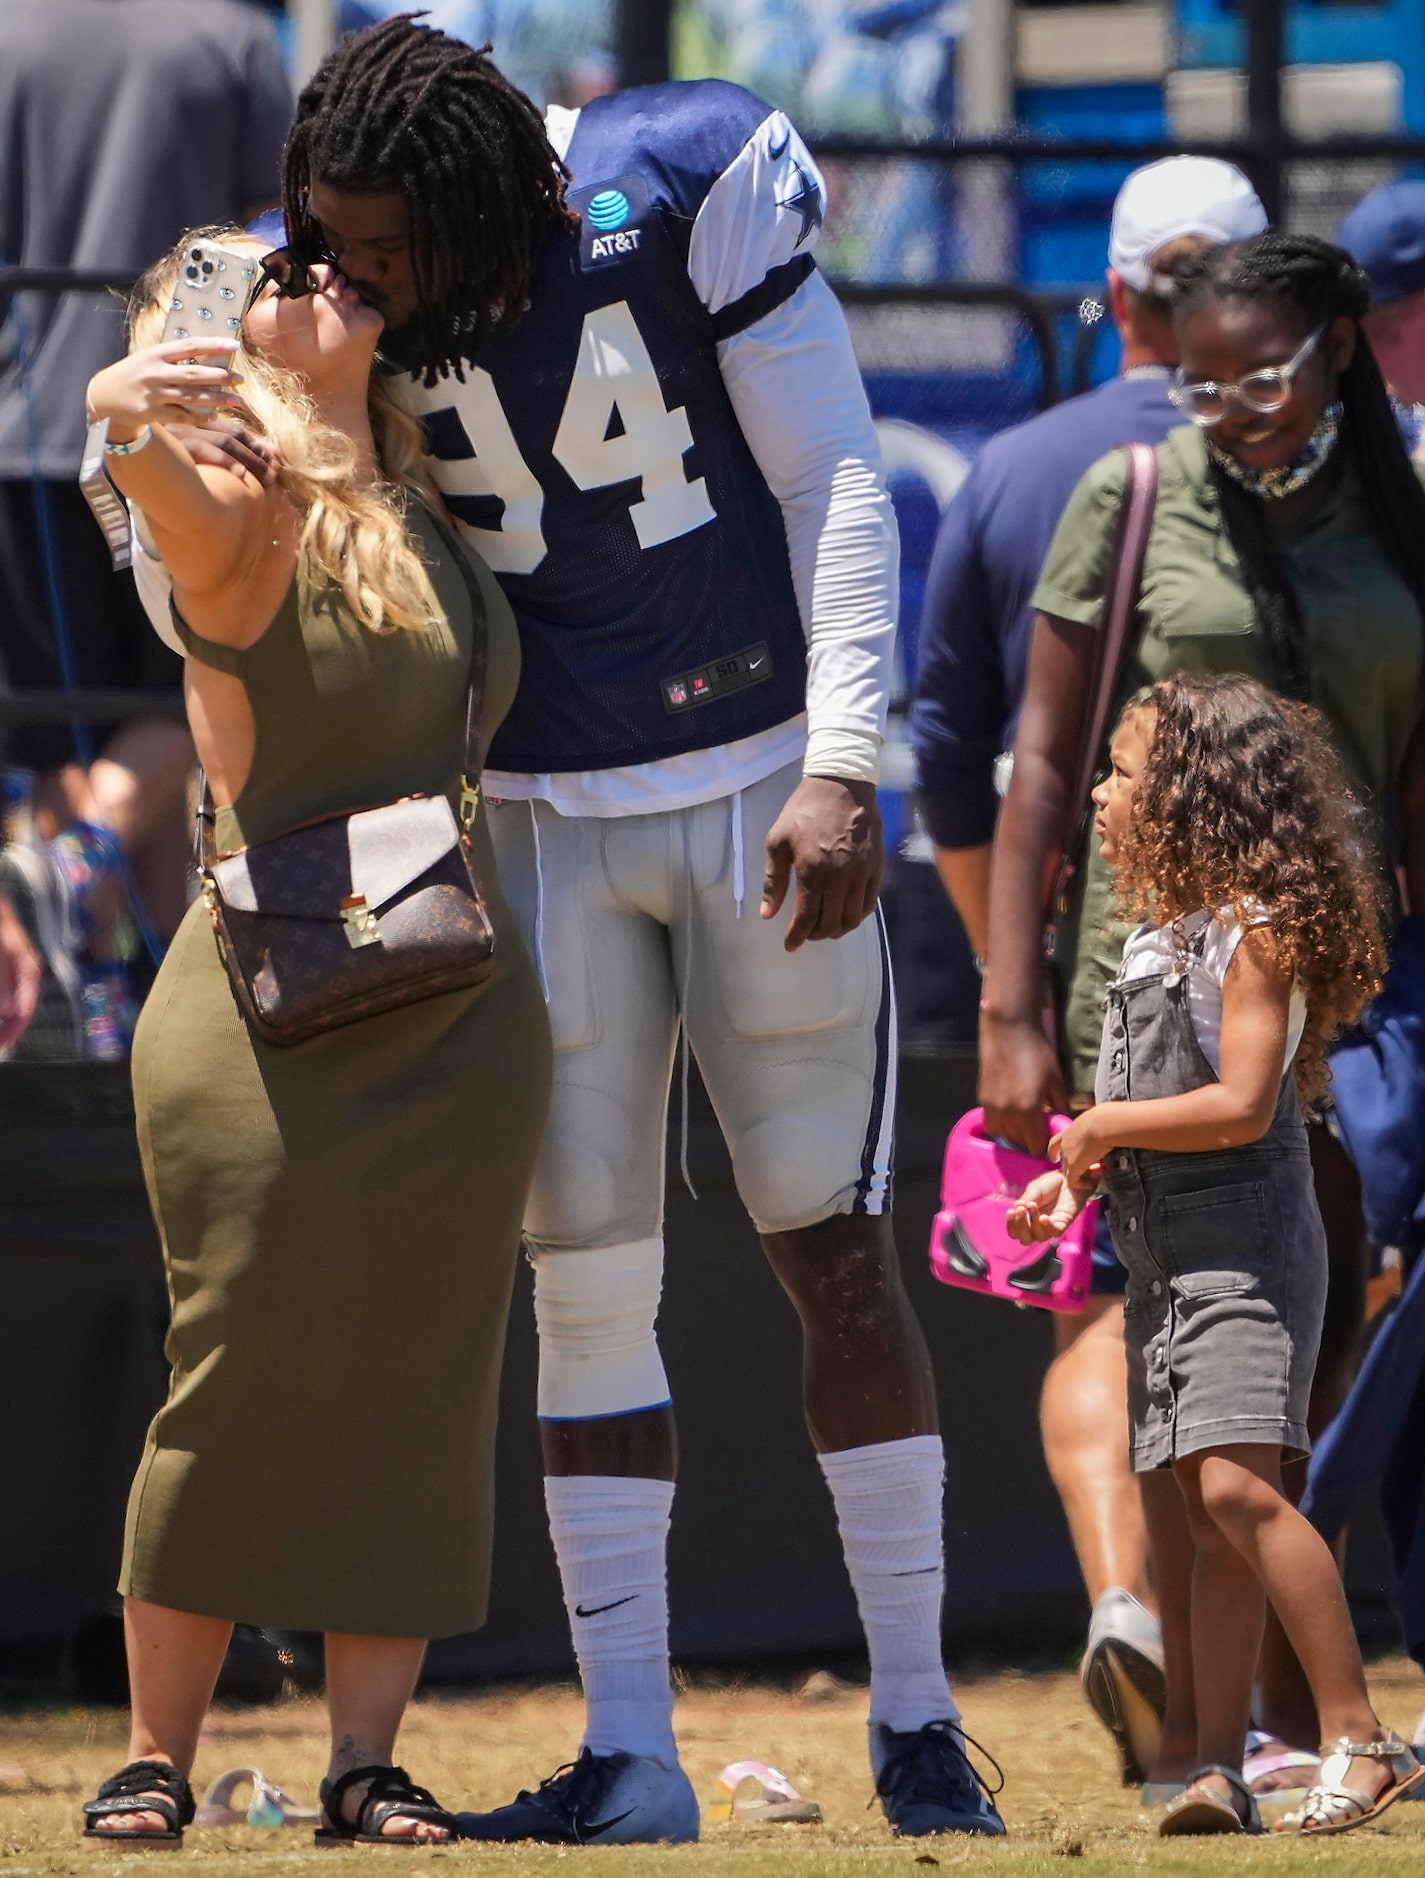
[[128, 225, 439, 633]]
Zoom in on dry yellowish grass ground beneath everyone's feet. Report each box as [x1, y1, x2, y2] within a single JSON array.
[[0, 1660, 1425, 1878]]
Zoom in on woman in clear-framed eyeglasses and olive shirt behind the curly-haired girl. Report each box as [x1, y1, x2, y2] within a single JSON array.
[[980, 231, 1425, 1802]]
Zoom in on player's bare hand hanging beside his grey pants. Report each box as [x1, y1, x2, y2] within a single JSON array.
[[762, 776, 886, 952]]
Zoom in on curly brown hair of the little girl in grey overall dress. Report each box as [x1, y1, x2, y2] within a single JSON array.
[[1115, 676, 1386, 1102]]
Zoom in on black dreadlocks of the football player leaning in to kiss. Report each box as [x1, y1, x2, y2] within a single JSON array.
[[282, 13, 578, 385]]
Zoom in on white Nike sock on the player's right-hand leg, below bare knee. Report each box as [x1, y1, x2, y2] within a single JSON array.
[[817, 1435, 959, 1747]]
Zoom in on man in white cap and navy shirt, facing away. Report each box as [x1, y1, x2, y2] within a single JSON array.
[[911, 156, 1265, 1780]]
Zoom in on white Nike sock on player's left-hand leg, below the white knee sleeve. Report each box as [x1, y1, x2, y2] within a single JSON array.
[[544, 1474, 678, 1767]]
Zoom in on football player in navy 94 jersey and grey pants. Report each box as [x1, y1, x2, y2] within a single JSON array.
[[131, 17, 1004, 1844]]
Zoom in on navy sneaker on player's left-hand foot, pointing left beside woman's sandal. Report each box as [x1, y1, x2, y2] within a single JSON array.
[[456, 1748, 698, 1846]]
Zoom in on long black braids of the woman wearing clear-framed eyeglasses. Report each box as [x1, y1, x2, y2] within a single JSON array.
[[1173, 229, 1425, 699]]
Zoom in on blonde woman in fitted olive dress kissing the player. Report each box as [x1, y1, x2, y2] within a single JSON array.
[[84, 231, 550, 1844]]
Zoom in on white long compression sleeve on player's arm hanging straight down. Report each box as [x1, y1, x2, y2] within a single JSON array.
[[717, 274, 899, 783]]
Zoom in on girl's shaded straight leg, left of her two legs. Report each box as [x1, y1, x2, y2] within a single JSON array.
[[1173, 1454, 1267, 1810]]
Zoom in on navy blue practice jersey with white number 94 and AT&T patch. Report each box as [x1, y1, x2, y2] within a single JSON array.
[[396, 81, 824, 774]]
